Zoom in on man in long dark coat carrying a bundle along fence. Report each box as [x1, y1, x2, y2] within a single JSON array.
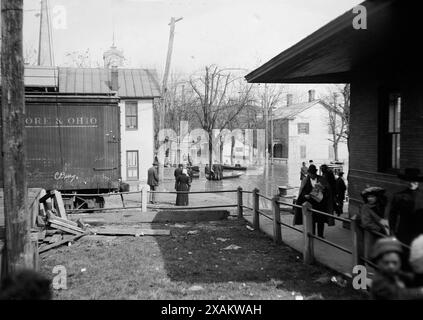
[[294, 164, 333, 238]]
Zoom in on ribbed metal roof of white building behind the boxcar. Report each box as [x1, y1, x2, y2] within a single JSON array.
[[59, 68, 160, 98]]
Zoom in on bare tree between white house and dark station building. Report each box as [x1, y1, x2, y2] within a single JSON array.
[[324, 84, 350, 161]]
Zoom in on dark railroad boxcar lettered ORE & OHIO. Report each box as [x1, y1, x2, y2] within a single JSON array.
[[0, 94, 121, 207]]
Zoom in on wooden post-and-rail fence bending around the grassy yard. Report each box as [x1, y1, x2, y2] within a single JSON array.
[[63, 187, 409, 276]]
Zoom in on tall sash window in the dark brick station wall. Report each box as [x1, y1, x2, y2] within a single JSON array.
[[379, 91, 402, 173]]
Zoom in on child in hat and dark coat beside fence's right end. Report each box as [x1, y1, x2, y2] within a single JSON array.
[[360, 187, 389, 257]]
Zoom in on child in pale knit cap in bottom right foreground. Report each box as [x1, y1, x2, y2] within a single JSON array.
[[370, 237, 423, 300]]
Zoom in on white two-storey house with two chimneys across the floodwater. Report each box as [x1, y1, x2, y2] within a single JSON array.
[[269, 90, 348, 163]]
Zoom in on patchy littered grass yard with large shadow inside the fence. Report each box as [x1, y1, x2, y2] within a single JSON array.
[[41, 220, 370, 299]]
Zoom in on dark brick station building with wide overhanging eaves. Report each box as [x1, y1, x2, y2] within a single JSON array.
[[246, 0, 423, 218]]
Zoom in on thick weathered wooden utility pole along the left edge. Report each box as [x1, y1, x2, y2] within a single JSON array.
[[1, 0, 33, 274]]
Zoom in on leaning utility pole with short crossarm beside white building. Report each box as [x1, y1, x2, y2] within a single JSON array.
[[159, 17, 183, 179]]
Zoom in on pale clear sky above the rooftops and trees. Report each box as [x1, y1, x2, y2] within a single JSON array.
[[24, 0, 362, 75]]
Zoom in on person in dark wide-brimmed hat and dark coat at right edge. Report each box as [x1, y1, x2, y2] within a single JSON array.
[[389, 168, 423, 245]]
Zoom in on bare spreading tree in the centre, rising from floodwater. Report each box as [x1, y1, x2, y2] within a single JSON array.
[[189, 65, 252, 166]]
